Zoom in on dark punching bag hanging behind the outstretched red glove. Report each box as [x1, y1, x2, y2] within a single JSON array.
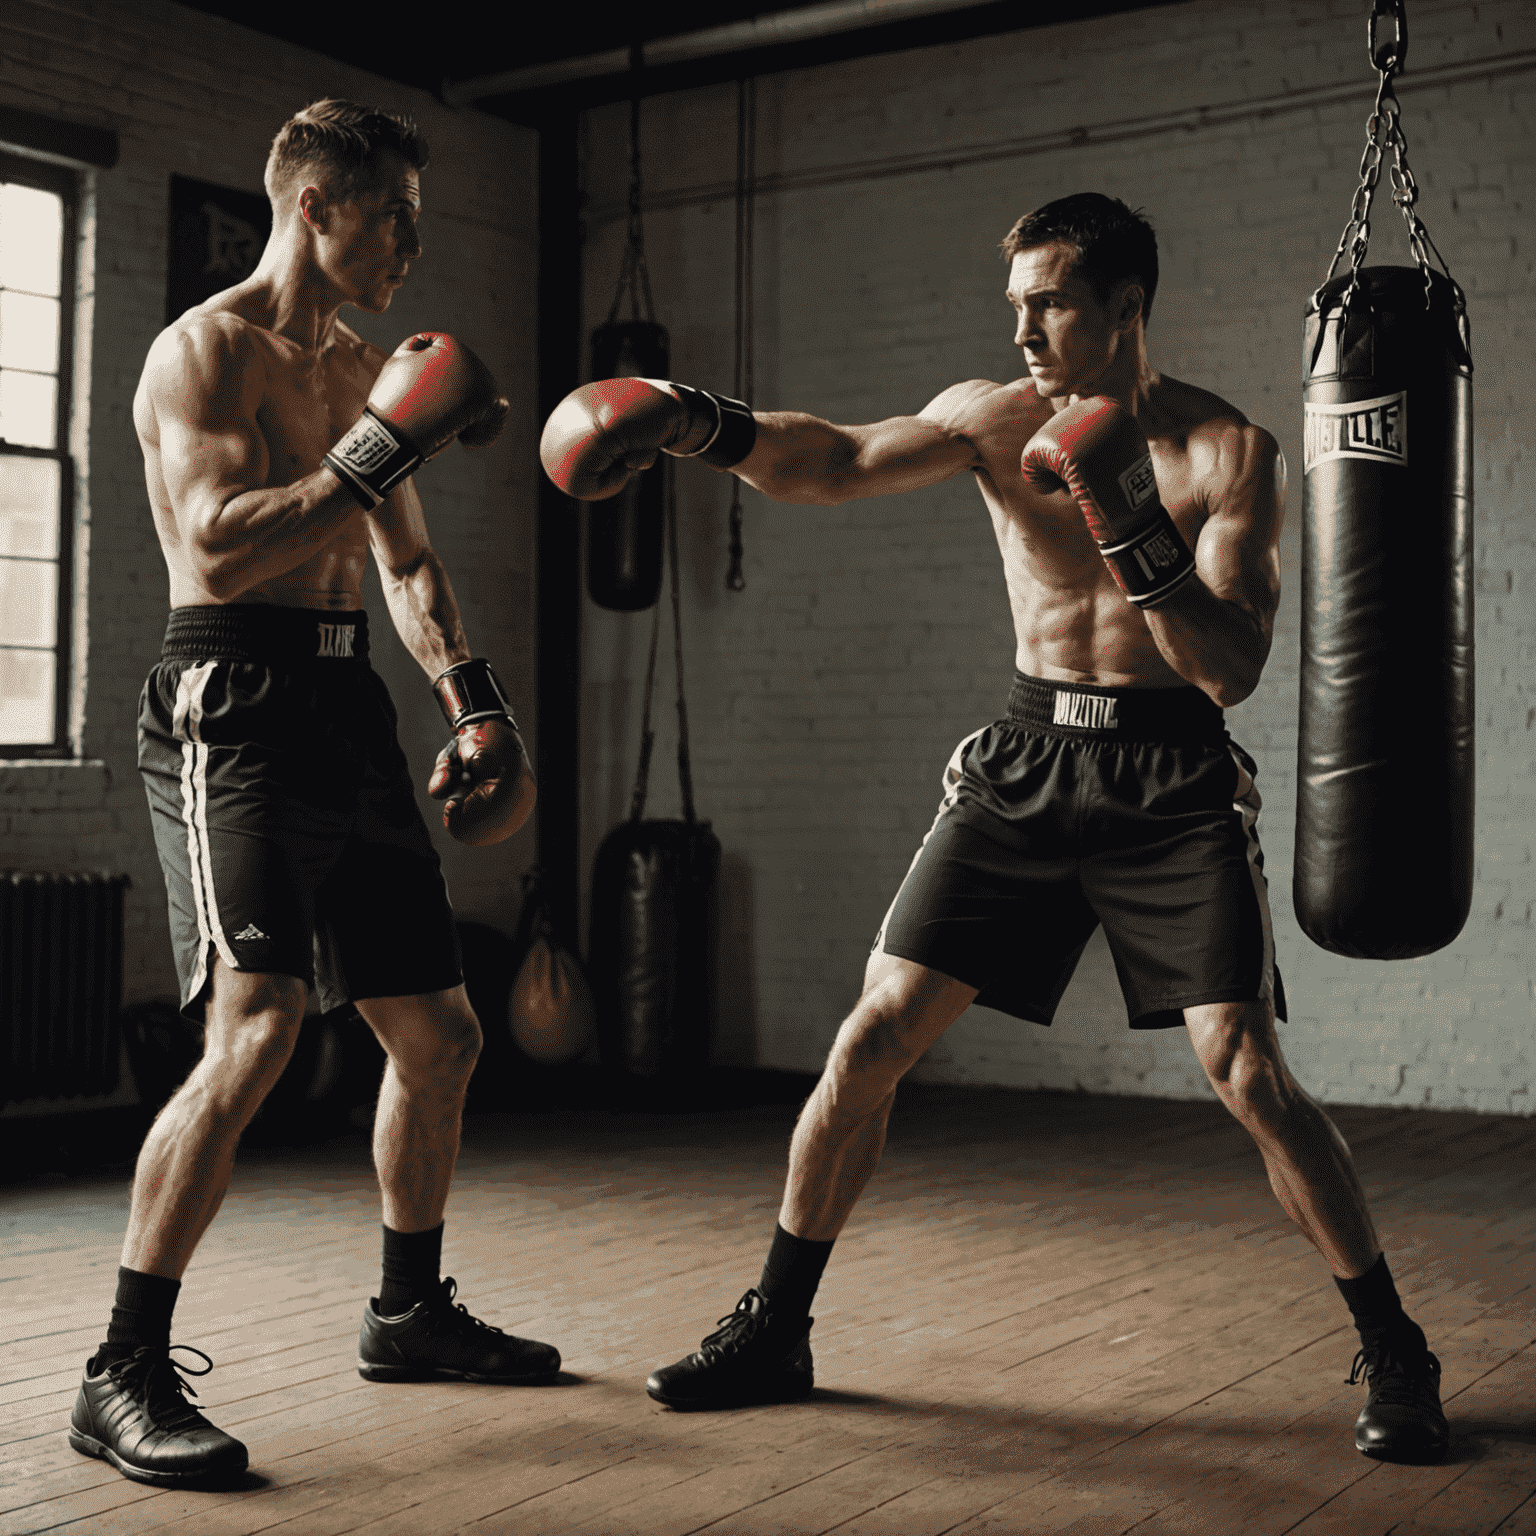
[[587, 319, 671, 613]]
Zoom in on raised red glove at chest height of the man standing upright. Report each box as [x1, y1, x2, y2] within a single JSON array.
[[326, 330, 511, 511]]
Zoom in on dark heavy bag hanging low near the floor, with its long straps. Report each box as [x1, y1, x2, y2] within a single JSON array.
[[588, 466, 720, 1089]]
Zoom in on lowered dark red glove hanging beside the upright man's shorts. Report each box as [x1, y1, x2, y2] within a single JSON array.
[[427, 657, 536, 848]]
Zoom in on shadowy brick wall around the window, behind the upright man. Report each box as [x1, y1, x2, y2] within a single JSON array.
[[0, 0, 538, 1032]]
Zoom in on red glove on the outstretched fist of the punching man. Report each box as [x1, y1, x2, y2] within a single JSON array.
[[539, 378, 757, 501]]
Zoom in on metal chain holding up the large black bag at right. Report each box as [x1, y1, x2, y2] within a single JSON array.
[[1313, 0, 1471, 352]]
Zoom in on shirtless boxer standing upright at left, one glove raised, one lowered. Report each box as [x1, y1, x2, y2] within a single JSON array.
[[69, 101, 559, 1485]]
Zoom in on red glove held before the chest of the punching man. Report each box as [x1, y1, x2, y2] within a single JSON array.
[[1020, 395, 1195, 608]]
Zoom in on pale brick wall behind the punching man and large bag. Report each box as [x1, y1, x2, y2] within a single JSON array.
[[582, 0, 1536, 1112]]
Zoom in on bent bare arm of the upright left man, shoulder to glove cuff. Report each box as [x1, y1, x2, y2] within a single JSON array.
[[144, 316, 371, 601]]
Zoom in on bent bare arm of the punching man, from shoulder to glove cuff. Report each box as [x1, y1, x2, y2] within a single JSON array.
[[1146, 421, 1286, 707]]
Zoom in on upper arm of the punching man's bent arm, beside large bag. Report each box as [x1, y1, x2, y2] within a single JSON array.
[[1195, 425, 1286, 636]]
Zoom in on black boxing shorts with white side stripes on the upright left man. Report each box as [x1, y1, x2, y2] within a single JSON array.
[[138, 604, 462, 1021]]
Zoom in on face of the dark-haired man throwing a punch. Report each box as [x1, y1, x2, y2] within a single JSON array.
[[1008, 241, 1135, 399]]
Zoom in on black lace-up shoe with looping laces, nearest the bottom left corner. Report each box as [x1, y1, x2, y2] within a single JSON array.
[[69, 1344, 249, 1488]]
